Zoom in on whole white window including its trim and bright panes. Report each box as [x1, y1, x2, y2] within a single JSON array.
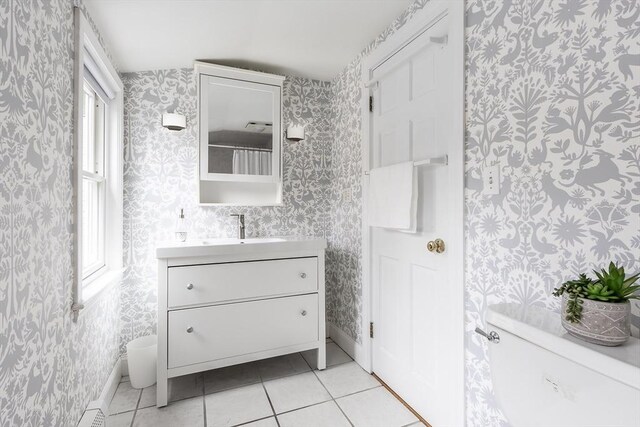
[[71, 8, 124, 320]]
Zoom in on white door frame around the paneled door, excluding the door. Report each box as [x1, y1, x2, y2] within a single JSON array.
[[356, 0, 466, 426]]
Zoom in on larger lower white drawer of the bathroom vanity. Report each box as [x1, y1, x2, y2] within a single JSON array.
[[168, 294, 318, 368]]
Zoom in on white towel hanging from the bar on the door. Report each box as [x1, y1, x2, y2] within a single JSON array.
[[369, 162, 418, 233]]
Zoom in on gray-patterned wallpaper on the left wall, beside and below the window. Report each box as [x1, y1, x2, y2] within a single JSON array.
[[0, 0, 120, 427]]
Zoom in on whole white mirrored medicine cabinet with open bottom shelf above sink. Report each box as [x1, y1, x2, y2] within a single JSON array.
[[195, 62, 284, 206]]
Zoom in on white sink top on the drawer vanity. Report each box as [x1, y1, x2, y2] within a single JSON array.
[[156, 237, 327, 258]]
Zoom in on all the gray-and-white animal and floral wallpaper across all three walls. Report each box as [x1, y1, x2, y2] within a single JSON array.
[[0, 0, 640, 426]]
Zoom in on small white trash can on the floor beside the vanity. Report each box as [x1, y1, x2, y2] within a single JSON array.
[[127, 335, 158, 388]]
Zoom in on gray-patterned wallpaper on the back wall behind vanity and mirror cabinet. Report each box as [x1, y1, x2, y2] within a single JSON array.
[[120, 69, 332, 352]]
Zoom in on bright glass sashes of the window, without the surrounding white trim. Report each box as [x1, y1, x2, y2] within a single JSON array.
[[82, 78, 108, 283]]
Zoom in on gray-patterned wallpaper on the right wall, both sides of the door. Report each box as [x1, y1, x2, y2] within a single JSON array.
[[328, 0, 640, 427]]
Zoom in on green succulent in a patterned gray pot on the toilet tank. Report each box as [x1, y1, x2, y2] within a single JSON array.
[[553, 262, 640, 346]]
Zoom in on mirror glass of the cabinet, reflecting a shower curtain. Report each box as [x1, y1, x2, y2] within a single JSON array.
[[208, 80, 273, 175]]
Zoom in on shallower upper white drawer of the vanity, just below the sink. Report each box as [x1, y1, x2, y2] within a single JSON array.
[[167, 257, 318, 307]]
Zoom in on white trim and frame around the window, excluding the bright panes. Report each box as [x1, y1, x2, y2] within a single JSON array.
[[71, 7, 124, 320]]
